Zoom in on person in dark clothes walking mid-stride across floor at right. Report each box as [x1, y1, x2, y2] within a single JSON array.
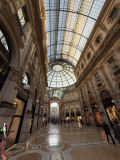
[[103, 121, 116, 145]]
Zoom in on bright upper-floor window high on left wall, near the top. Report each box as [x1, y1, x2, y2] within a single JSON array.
[[18, 6, 29, 28]]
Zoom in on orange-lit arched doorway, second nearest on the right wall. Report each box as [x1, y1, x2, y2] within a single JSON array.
[[90, 97, 102, 127]]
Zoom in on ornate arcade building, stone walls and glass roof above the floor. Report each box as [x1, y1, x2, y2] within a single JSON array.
[[0, 0, 120, 157]]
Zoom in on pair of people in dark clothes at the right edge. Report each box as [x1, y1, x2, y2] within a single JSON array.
[[103, 121, 120, 145]]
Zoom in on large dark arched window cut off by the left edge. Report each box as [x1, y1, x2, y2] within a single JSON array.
[[0, 29, 11, 90]]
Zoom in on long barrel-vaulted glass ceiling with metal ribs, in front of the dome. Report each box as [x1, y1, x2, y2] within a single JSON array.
[[44, 0, 105, 87]]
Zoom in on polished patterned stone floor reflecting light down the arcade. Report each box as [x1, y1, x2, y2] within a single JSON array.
[[5, 122, 120, 160]]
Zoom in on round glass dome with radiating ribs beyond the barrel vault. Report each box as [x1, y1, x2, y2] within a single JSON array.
[[47, 62, 76, 88]]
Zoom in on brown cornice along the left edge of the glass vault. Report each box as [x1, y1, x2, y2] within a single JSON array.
[[26, 0, 48, 86]]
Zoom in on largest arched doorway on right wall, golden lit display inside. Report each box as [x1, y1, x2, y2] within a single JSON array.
[[100, 90, 120, 127]]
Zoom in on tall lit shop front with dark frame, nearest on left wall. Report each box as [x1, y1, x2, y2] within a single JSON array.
[[6, 83, 28, 148]]
